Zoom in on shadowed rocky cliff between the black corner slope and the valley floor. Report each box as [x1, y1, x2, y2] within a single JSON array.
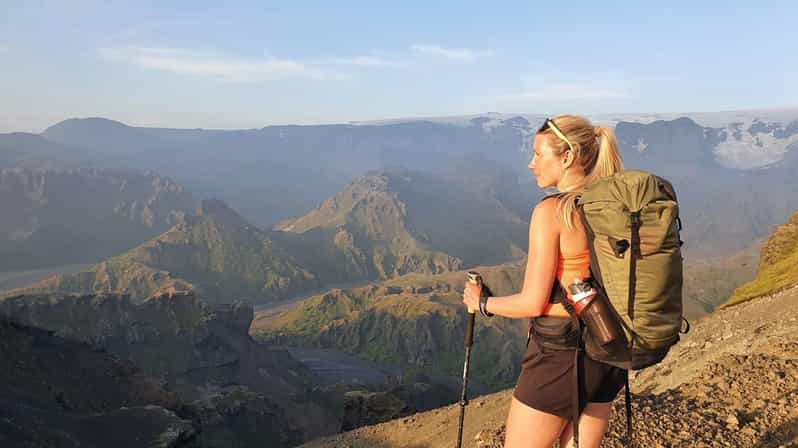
[[0, 295, 341, 446]]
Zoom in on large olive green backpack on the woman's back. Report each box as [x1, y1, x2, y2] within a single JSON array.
[[577, 170, 686, 370]]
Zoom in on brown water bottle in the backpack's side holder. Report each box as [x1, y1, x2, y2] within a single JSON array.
[[568, 279, 619, 345]]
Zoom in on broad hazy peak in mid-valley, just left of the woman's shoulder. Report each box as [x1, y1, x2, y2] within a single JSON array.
[[276, 168, 527, 279]]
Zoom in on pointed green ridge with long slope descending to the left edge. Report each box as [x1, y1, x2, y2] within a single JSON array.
[[6, 200, 317, 302]]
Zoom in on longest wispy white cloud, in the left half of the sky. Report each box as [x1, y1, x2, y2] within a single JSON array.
[[100, 47, 328, 81]]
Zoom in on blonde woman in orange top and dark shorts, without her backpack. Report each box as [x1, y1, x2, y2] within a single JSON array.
[[463, 115, 624, 448]]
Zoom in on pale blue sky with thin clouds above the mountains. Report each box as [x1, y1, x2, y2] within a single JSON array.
[[0, 0, 798, 132]]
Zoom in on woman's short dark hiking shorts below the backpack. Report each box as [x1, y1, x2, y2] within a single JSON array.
[[513, 320, 626, 420]]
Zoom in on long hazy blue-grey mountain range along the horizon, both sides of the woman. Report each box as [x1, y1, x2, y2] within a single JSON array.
[[29, 110, 798, 253]]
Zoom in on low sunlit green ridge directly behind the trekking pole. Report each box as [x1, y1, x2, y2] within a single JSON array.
[[250, 263, 526, 387]]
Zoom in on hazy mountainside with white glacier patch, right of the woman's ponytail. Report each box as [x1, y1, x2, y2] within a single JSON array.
[[616, 118, 798, 255]]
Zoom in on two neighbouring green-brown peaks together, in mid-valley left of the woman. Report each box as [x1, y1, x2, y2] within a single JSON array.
[[7, 169, 527, 303]]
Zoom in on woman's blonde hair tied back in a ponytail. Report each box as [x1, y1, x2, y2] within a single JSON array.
[[540, 115, 623, 230]]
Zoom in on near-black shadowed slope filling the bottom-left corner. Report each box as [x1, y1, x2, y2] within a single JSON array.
[[0, 318, 195, 448]]
